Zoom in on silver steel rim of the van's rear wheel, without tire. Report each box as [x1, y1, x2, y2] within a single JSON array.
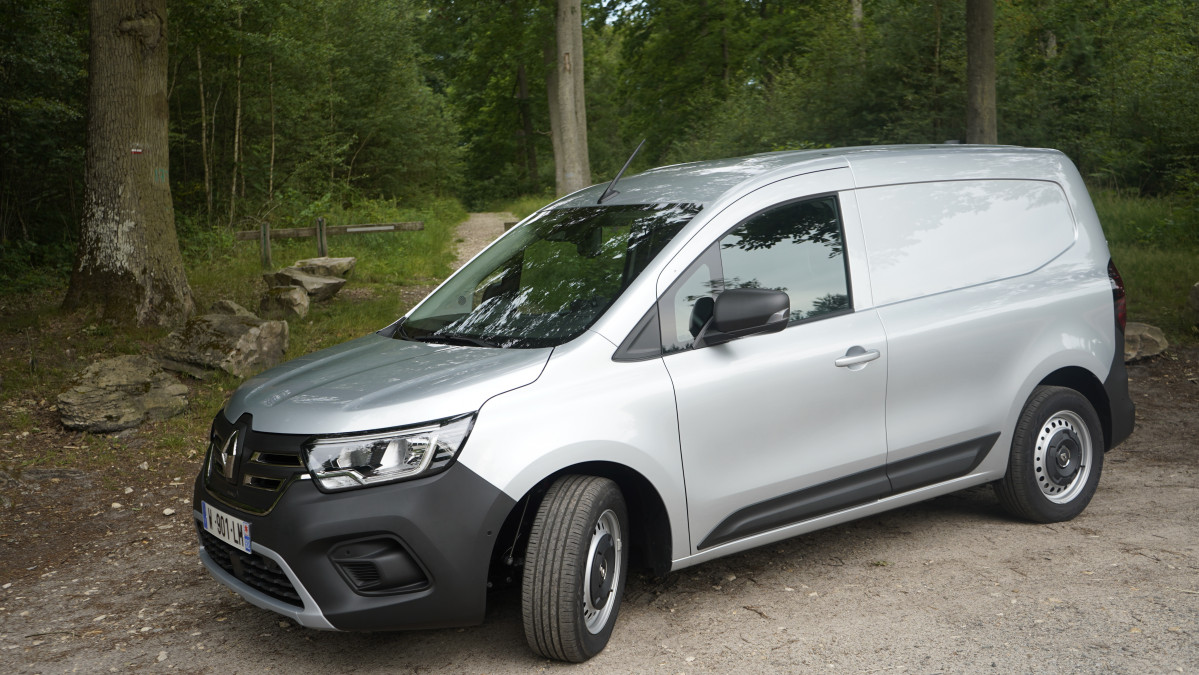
[[1032, 410, 1095, 504]]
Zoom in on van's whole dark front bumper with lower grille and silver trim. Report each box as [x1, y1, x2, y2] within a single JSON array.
[[194, 464, 514, 631]]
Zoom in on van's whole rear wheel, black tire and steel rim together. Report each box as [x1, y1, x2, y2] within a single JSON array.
[[995, 386, 1104, 523]]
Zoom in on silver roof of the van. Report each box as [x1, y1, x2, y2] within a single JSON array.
[[552, 144, 1064, 209]]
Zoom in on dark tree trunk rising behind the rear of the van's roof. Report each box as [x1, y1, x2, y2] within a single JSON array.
[[966, 0, 999, 145]]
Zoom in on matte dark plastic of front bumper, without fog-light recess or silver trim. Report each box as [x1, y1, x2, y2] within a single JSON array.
[[194, 464, 516, 631]]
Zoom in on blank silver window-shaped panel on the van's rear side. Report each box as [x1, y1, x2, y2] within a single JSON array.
[[857, 180, 1074, 305]]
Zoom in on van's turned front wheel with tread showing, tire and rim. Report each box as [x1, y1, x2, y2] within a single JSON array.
[[520, 476, 628, 663]]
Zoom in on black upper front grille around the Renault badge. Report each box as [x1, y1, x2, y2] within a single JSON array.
[[204, 412, 308, 516]]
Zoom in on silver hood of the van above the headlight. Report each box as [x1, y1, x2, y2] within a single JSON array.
[[224, 335, 553, 434]]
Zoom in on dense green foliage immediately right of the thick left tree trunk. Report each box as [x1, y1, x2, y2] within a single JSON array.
[[171, 0, 462, 223]]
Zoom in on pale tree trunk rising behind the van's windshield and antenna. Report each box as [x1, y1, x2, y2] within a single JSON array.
[[547, 0, 591, 197]]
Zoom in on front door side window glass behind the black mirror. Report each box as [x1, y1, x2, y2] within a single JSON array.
[[658, 195, 851, 351]]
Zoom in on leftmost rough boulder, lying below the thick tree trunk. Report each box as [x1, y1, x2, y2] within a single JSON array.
[[59, 355, 187, 433]]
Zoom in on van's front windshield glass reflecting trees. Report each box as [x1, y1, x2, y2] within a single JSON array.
[[394, 204, 700, 348]]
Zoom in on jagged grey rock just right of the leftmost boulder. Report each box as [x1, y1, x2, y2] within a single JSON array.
[[161, 314, 288, 379]]
